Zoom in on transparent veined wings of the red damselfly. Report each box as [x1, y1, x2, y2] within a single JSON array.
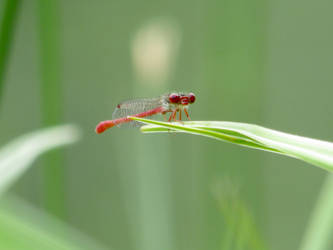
[[112, 98, 163, 127]]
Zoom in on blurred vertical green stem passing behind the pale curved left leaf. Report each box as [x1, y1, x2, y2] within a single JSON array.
[[38, 0, 66, 218]]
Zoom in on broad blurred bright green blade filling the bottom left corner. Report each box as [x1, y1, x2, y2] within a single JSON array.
[[0, 195, 110, 250]]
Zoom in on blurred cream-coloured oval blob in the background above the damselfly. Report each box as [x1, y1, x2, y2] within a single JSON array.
[[132, 19, 180, 85]]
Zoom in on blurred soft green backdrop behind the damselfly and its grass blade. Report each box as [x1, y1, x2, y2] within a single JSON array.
[[0, 0, 333, 250]]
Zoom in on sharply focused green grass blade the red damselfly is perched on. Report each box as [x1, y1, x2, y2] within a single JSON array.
[[131, 117, 333, 171]]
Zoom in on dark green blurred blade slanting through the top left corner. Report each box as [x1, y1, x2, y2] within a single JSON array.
[[0, 0, 21, 100]]
